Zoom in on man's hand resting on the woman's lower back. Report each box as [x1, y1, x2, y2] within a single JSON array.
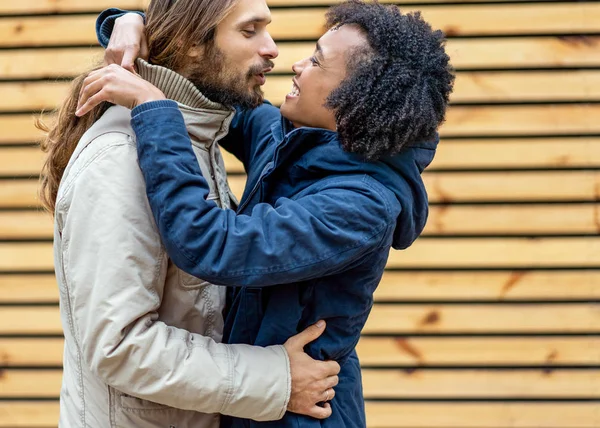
[[284, 321, 340, 419]]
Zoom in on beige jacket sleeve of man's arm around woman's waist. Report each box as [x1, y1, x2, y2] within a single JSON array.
[[57, 138, 291, 421]]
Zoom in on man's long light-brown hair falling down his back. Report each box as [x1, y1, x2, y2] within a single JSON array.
[[36, 0, 239, 214]]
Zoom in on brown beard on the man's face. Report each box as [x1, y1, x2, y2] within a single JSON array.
[[188, 44, 273, 108]]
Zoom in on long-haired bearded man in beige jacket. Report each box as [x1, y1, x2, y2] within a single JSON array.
[[42, 0, 339, 428]]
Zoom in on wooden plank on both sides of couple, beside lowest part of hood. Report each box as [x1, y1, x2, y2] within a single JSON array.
[[0, 204, 600, 240]]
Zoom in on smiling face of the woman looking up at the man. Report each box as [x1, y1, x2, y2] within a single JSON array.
[[281, 25, 367, 131]]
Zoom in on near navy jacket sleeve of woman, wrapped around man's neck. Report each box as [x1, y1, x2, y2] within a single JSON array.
[[132, 101, 397, 287]]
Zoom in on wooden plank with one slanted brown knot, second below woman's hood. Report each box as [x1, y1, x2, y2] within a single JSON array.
[[375, 270, 600, 302]]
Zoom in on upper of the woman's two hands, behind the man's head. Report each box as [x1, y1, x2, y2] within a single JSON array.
[[104, 13, 149, 73]]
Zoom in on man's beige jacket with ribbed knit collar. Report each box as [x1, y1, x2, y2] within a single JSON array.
[[54, 63, 291, 428]]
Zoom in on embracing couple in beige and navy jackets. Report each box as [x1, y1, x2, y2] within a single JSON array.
[[41, 0, 454, 428]]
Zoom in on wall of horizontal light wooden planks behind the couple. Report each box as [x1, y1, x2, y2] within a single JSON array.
[[0, 0, 600, 428]]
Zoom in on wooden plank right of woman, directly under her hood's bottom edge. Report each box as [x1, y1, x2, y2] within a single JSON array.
[[388, 237, 600, 269]]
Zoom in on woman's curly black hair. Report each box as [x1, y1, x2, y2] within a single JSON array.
[[325, 0, 454, 160]]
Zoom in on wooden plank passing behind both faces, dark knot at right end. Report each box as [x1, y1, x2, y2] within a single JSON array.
[[0, 36, 600, 79]]
